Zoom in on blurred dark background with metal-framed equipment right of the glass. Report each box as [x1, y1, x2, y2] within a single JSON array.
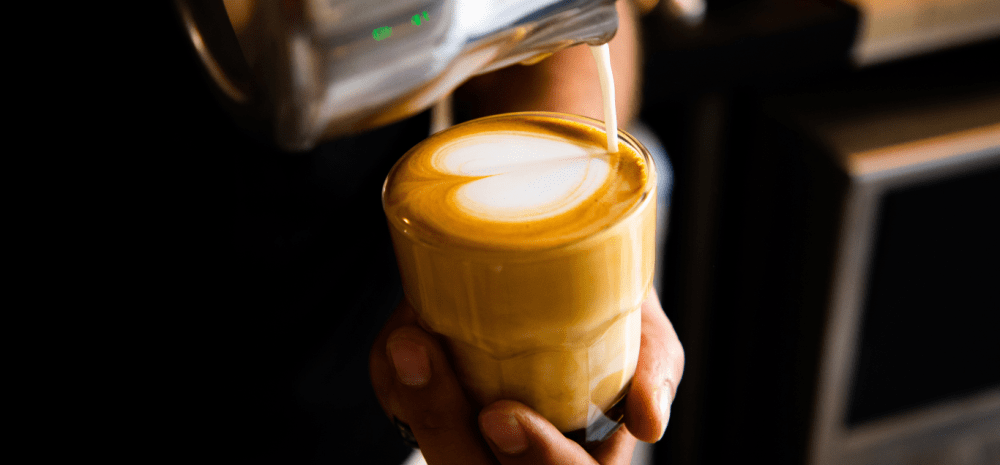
[[642, 0, 1000, 465]]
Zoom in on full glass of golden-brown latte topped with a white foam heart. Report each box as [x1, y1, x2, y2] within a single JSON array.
[[383, 113, 656, 438]]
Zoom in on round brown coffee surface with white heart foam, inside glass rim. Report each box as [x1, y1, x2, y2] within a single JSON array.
[[384, 114, 647, 249]]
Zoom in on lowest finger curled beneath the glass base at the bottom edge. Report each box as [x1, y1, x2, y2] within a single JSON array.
[[479, 400, 636, 465]]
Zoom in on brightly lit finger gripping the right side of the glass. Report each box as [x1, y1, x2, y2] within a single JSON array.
[[625, 292, 684, 442]]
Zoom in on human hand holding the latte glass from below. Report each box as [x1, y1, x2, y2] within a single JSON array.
[[369, 292, 684, 465]]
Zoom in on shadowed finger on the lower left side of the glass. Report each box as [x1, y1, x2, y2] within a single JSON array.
[[371, 300, 495, 465]]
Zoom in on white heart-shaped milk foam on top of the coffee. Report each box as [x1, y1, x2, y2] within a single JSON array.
[[433, 131, 612, 222]]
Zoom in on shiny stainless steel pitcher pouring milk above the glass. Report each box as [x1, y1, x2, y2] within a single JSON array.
[[175, 0, 618, 150]]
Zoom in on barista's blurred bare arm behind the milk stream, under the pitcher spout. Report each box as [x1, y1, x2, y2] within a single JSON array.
[[454, 0, 656, 128]]
